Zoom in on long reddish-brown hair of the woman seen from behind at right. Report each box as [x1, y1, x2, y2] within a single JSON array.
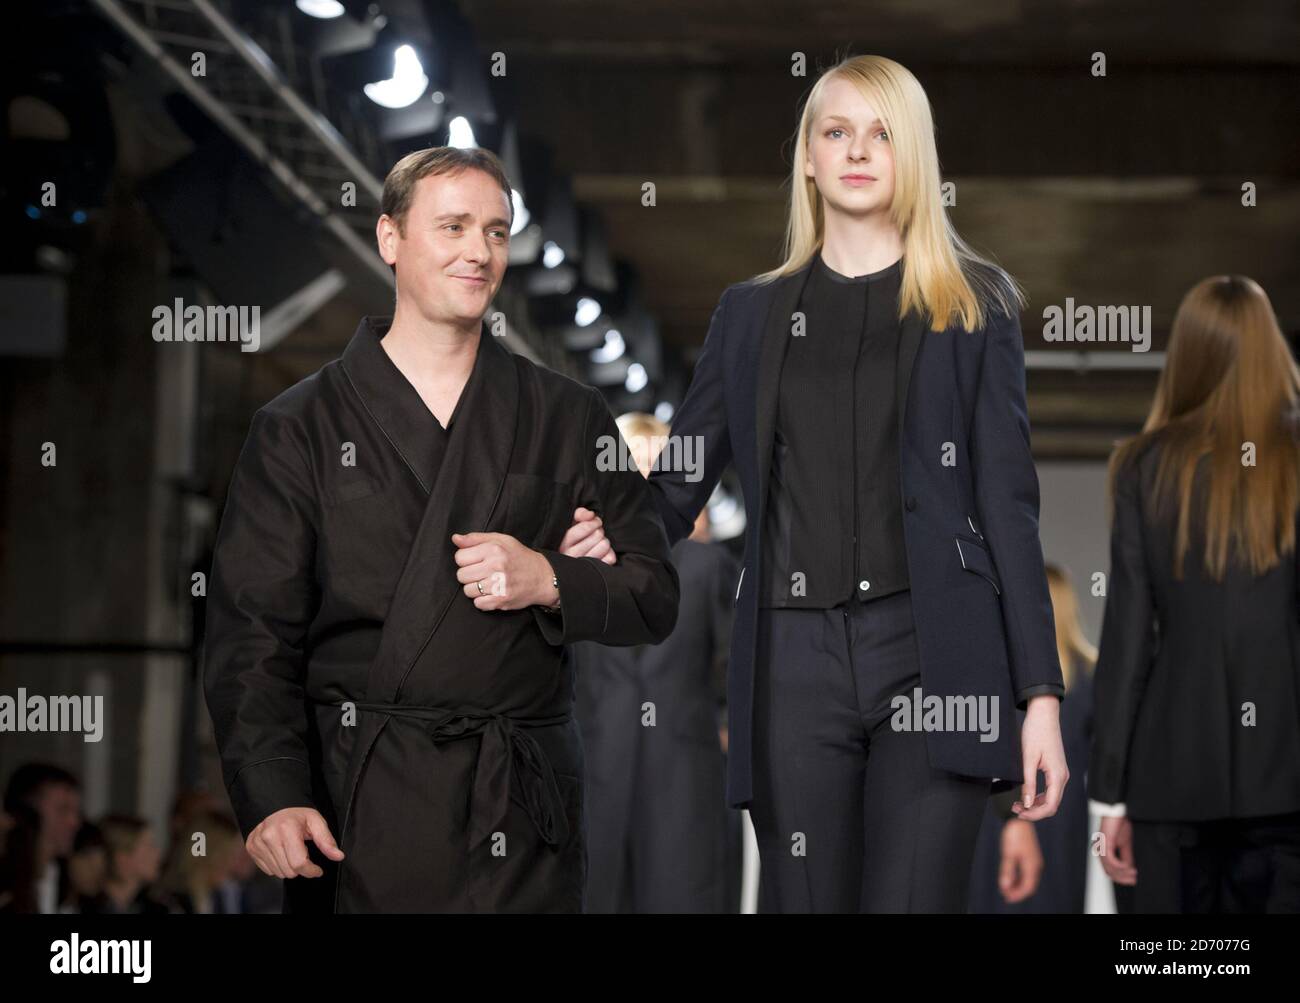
[[1110, 275, 1300, 581]]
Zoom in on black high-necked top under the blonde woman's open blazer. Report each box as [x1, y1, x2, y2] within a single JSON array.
[[759, 255, 909, 609]]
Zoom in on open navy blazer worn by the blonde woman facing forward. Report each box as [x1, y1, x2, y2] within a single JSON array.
[[650, 265, 1065, 808]]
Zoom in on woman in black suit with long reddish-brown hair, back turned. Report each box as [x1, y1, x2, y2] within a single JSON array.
[[1088, 275, 1300, 912]]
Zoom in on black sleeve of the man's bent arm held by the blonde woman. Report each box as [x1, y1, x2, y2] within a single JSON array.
[[533, 388, 679, 644]]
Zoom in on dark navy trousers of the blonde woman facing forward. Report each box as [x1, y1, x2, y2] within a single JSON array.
[[750, 591, 992, 912]]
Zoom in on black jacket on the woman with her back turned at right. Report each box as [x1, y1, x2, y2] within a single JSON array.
[[1088, 437, 1300, 821]]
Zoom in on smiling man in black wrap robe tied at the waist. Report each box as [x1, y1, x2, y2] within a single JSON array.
[[204, 148, 679, 912]]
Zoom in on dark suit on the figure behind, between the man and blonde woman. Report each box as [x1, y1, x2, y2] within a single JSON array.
[[571, 539, 738, 912]]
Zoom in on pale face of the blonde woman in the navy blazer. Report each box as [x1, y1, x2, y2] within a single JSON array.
[[803, 78, 894, 218]]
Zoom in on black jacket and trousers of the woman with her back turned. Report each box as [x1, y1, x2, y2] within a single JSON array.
[[1088, 440, 1300, 912]]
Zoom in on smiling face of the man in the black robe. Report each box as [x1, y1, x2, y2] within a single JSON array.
[[376, 169, 510, 326]]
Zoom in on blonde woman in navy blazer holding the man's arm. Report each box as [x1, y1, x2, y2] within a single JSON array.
[[572, 56, 1067, 912]]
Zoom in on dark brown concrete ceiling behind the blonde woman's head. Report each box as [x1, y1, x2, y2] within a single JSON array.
[[464, 0, 1300, 456]]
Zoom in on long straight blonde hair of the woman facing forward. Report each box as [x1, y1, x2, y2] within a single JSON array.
[[755, 56, 1024, 331]]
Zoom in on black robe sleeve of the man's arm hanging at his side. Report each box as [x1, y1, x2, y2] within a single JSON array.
[[204, 409, 320, 838]]
